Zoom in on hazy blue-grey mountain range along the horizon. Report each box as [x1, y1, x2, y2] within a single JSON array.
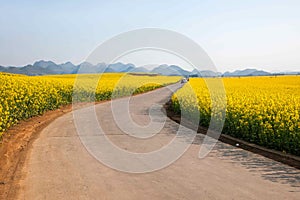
[[0, 60, 300, 77]]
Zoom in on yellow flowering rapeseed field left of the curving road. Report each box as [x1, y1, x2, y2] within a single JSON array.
[[0, 73, 180, 135]]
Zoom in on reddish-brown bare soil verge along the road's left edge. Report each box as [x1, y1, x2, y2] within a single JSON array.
[[0, 105, 72, 199]]
